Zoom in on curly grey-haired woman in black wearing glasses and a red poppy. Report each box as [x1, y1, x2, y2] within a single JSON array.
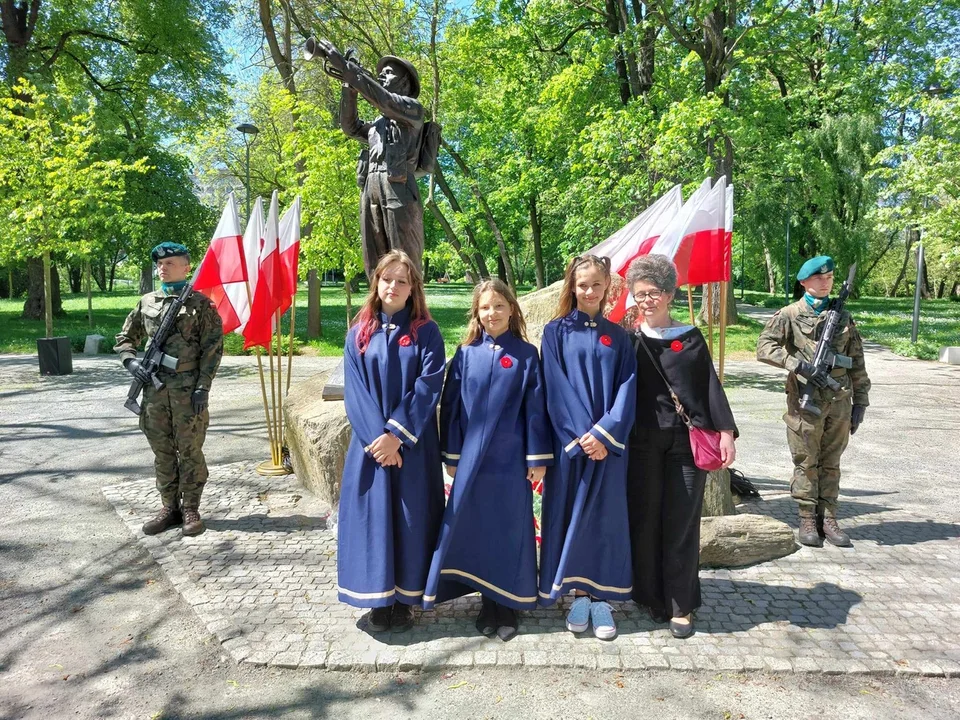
[[626, 255, 737, 638]]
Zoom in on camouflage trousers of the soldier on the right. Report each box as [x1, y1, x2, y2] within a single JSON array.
[[783, 394, 853, 517]]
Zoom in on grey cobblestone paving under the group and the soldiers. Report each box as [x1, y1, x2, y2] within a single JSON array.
[[103, 463, 960, 677]]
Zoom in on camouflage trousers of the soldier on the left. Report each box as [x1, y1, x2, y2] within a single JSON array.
[[140, 384, 210, 507]]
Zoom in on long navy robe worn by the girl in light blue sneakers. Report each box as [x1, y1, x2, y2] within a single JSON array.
[[539, 310, 637, 605]]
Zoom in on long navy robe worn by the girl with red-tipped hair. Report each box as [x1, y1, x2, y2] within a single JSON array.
[[337, 308, 446, 607]]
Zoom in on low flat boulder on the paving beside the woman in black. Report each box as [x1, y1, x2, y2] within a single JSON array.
[[700, 515, 799, 567]]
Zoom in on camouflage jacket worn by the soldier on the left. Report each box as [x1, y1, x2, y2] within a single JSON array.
[[113, 290, 223, 390]]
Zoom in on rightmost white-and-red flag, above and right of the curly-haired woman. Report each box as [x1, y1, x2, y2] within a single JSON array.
[[650, 177, 730, 287]]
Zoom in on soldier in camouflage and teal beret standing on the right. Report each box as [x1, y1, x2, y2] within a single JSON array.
[[757, 255, 870, 547]]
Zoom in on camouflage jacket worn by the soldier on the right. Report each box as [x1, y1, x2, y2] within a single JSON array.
[[757, 298, 870, 405]]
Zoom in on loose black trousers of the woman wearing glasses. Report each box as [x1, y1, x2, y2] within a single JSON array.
[[627, 427, 707, 617]]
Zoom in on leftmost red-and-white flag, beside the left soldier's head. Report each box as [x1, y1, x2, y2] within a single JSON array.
[[193, 193, 247, 332]]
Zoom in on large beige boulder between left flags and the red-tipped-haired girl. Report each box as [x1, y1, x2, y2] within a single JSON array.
[[283, 372, 351, 505]]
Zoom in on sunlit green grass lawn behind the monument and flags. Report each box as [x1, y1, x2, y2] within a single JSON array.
[[0, 284, 960, 360]]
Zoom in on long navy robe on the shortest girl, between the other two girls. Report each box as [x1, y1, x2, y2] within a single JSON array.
[[423, 331, 553, 609]]
